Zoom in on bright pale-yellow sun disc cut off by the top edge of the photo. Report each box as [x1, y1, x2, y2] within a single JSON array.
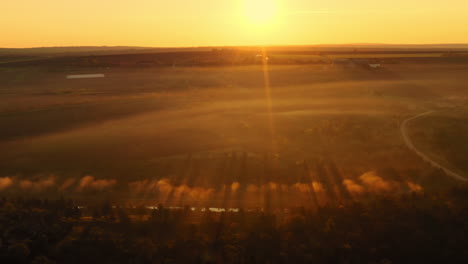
[[244, 0, 278, 25]]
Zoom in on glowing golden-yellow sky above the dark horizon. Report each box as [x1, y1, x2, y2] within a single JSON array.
[[0, 0, 468, 47]]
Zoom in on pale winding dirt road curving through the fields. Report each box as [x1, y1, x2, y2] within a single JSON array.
[[400, 111, 468, 182]]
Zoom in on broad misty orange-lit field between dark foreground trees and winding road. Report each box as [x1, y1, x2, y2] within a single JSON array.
[[0, 59, 467, 206]]
